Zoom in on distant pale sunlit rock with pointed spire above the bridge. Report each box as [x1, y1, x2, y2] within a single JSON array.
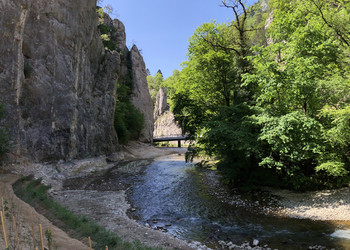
[[153, 87, 182, 137]]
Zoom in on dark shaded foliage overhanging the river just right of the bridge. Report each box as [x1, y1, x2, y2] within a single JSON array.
[[197, 104, 259, 185]]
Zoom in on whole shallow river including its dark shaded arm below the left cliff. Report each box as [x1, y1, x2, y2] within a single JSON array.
[[58, 151, 350, 249]]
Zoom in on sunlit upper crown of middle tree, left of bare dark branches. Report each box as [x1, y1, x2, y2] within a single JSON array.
[[183, 23, 240, 106]]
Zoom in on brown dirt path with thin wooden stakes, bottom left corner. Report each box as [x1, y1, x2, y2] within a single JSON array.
[[0, 174, 89, 250]]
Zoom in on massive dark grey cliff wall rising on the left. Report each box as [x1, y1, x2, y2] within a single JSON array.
[[0, 0, 153, 161]]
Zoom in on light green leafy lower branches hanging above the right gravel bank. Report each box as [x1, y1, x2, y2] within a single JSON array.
[[258, 112, 325, 189]]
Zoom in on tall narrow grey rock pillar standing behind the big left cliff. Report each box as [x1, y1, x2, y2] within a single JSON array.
[[130, 45, 154, 142]]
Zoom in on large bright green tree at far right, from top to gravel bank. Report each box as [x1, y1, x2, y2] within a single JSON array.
[[244, 0, 350, 189]]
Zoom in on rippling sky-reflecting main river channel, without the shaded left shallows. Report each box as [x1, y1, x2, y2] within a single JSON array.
[[129, 155, 350, 249]]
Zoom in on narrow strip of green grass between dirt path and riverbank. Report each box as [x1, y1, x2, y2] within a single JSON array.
[[13, 177, 161, 250]]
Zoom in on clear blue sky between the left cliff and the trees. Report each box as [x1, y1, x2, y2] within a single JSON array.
[[102, 0, 256, 78]]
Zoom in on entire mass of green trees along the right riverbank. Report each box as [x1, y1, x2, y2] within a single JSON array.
[[166, 0, 350, 190]]
